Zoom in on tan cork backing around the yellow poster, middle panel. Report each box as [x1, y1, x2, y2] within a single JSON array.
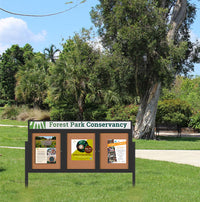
[[67, 133, 95, 169]]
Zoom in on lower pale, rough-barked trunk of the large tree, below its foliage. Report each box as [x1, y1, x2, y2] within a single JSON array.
[[134, 82, 161, 139]]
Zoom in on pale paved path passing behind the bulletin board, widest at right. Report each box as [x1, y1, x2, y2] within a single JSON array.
[[0, 146, 200, 167]]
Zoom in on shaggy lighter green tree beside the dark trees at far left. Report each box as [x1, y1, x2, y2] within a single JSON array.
[[15, 53, 48, 108]]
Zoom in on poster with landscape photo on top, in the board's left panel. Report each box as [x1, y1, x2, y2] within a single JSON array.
[[35, 136, 56, 164]]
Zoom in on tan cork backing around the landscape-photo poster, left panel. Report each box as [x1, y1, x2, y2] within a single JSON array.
[[32, 133, 61, 169]]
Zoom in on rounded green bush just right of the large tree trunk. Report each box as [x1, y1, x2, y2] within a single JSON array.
[[156, 99, 192, 127]]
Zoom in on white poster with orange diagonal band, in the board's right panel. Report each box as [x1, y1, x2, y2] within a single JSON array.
[[107, 139, 126, 163]]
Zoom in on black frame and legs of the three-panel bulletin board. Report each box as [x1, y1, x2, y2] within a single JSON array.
[[25, 121, 135, 187]]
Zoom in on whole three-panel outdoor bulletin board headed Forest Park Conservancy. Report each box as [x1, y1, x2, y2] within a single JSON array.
[[25, 121, 135, 186]]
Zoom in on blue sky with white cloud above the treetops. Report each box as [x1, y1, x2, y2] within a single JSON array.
[[0, 0, 200, 76]]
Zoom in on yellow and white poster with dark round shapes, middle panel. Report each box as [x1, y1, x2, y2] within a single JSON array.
[[71, 139, 93, 161]]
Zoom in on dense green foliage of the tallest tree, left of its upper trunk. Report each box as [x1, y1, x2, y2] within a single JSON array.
[[91, 0, 168, 95]]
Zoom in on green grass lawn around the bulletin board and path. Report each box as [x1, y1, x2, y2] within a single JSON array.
[[0, 124, 200, 202]]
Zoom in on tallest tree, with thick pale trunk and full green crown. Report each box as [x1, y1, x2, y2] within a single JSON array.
[[91, 0, 197, 138]]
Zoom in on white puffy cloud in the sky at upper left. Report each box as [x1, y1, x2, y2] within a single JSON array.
[[0, 17, 46, 53]]
